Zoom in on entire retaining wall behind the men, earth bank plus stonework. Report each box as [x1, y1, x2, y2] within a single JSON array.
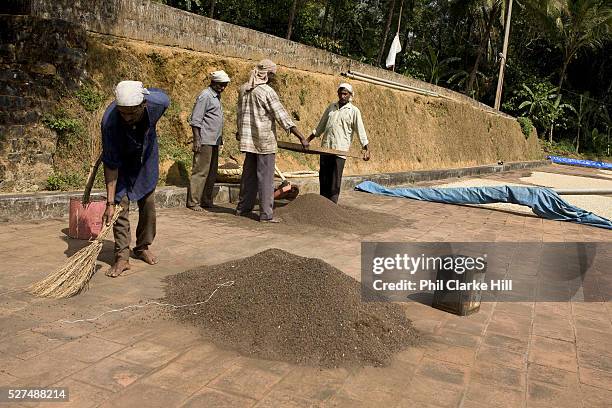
[[0, 0, 540, 192]]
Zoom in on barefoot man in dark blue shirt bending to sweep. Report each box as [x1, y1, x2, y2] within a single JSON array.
[[102, 81, 170, 278]]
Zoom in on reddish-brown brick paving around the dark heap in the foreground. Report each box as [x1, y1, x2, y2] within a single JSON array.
[[0, 167, 612, 408]]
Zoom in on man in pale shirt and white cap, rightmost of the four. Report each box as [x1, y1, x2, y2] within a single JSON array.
[[308, 83, 370, 203]]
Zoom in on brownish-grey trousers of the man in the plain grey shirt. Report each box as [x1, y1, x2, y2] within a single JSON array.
[[187, 145, 219, 207]]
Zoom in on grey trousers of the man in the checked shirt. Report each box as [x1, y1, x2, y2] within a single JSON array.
[[236, 153, 275, 220]]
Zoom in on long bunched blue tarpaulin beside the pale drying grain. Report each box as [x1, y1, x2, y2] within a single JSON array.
[[355, 181, 612, 229]]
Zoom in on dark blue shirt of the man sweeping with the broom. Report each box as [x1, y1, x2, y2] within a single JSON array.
[[102, 88, 170, 202]]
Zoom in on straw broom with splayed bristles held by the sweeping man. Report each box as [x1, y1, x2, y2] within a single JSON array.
[[28, 206, 123, 299]]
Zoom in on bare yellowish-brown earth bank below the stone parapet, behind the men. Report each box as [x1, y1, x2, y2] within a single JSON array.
[[61, 34, 542, 186]]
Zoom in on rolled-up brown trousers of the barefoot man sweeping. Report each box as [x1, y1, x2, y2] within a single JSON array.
[[113, 190, 156, 261]]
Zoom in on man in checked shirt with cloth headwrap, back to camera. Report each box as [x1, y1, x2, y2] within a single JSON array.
[[236, 59, 308, 222]]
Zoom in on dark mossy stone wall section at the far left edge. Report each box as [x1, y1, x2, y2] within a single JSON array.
[[0, 13, 87, 190]]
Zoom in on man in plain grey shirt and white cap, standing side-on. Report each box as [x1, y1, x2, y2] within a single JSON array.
[[187, 71, 230, 211]]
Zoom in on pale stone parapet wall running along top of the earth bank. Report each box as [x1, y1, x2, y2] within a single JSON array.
[[20, 0, 506, 114]]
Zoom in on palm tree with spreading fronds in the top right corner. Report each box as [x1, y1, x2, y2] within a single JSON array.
[[527, 0, 612, 99]]
